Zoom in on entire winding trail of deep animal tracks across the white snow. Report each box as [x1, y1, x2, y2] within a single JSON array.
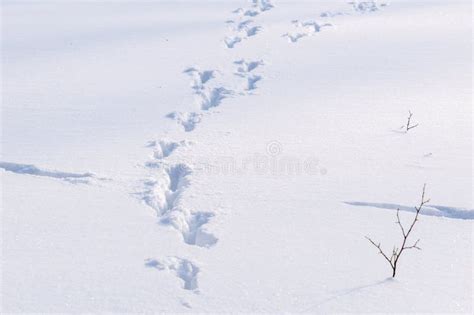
[[143, 0, 386, 298]]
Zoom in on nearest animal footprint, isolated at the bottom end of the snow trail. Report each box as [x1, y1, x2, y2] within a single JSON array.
[[145, 257, 199, 292]]
